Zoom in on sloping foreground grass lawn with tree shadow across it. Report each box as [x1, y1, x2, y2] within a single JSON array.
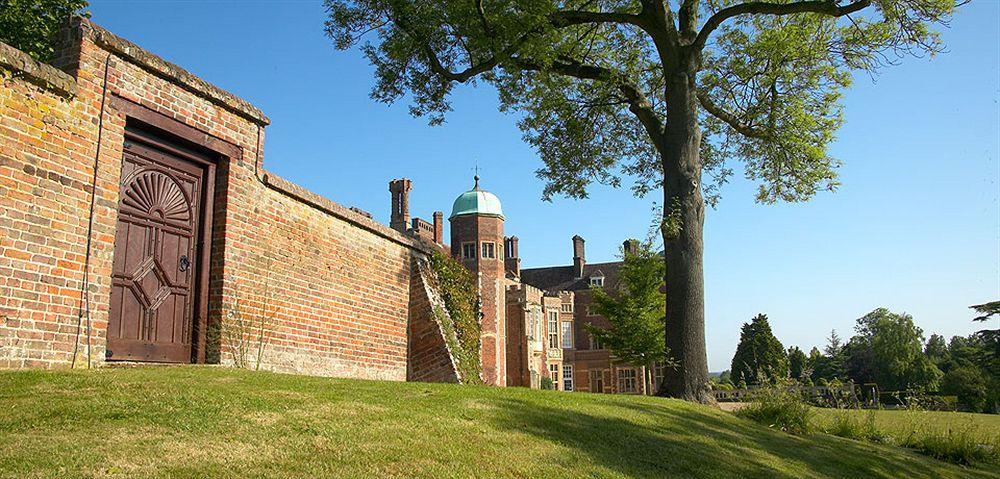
[[0, 366, 1000, 478]]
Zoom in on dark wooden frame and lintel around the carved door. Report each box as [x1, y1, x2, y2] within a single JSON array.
[[111, 95, 243, 364]]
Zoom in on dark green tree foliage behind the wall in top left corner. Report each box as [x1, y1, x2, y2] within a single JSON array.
[[0, 0, 88, 61]]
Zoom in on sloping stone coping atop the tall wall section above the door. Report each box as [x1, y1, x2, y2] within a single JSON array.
[[71, 17, 271, 126]]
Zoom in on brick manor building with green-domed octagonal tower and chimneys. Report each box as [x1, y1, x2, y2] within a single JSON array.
[[389, 176, 663, 394]]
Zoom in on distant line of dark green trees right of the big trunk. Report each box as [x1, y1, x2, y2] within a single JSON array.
[[715, 301, 1000, 413]]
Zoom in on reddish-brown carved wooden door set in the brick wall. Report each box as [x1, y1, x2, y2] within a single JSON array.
[[107, 135, 207, 363]]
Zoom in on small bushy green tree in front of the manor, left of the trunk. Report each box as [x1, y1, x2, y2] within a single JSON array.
[[586, 242, 667, 391]]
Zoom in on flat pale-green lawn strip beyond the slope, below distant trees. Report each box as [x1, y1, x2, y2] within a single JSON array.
[[814, 408, 1000, 439]]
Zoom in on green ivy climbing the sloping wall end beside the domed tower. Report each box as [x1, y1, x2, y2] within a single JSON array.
[[430, 252, 482, 384]]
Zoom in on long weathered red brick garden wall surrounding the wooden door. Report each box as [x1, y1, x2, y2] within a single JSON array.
[[0, 16, 426, 380]]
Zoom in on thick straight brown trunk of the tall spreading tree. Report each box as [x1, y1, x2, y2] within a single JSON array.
[[660, 69, 711, 402]]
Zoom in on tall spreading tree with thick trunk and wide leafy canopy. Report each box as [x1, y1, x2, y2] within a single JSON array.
[[325, 0, 954, 400]]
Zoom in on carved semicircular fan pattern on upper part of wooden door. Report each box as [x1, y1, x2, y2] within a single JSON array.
[[122, 170, 191, 222]]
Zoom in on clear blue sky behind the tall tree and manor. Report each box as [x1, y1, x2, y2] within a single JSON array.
[[90, 0, 1000, 371]]
